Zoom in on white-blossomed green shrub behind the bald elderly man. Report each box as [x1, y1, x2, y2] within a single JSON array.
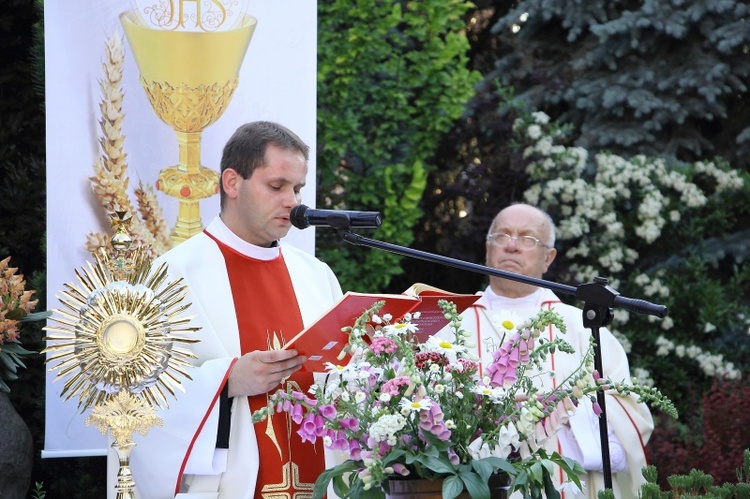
[[514, 112, 750, 412]]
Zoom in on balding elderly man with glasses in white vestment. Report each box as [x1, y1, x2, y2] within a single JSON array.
[[450, 204, 653, 499]]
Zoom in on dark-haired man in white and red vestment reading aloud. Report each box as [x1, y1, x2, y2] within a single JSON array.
[[109, 122, 342, 499]]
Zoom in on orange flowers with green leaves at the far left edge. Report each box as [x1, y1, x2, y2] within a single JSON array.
[[0, 257, 38, 393]]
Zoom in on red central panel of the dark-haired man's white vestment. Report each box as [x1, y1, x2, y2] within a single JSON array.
[[217, 241, 325, 499]]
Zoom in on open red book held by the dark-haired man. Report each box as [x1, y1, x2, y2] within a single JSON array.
[[282, 284, 479, 372]]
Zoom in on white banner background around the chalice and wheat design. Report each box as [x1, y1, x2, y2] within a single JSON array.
[[42, 0, 317, 457]]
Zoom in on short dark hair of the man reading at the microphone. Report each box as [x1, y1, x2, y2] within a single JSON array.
[[219, 121, 310, 208]]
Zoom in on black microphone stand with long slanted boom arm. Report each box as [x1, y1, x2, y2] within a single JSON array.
[[337, 227, 667, 489]]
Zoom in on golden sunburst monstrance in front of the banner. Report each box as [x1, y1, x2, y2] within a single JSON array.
[[43, 213, 198, 499]]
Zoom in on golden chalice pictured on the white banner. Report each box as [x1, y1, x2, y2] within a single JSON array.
[[120, 10, 257, 244]]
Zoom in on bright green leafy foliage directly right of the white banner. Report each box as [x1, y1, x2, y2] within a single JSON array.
[[317, 0, 479, 291]]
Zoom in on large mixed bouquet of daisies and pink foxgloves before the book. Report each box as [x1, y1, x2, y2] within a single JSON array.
[[253, 300, 676, 498]]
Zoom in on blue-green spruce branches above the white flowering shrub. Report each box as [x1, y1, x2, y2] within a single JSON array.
[[486, 0, 750, 166]]
